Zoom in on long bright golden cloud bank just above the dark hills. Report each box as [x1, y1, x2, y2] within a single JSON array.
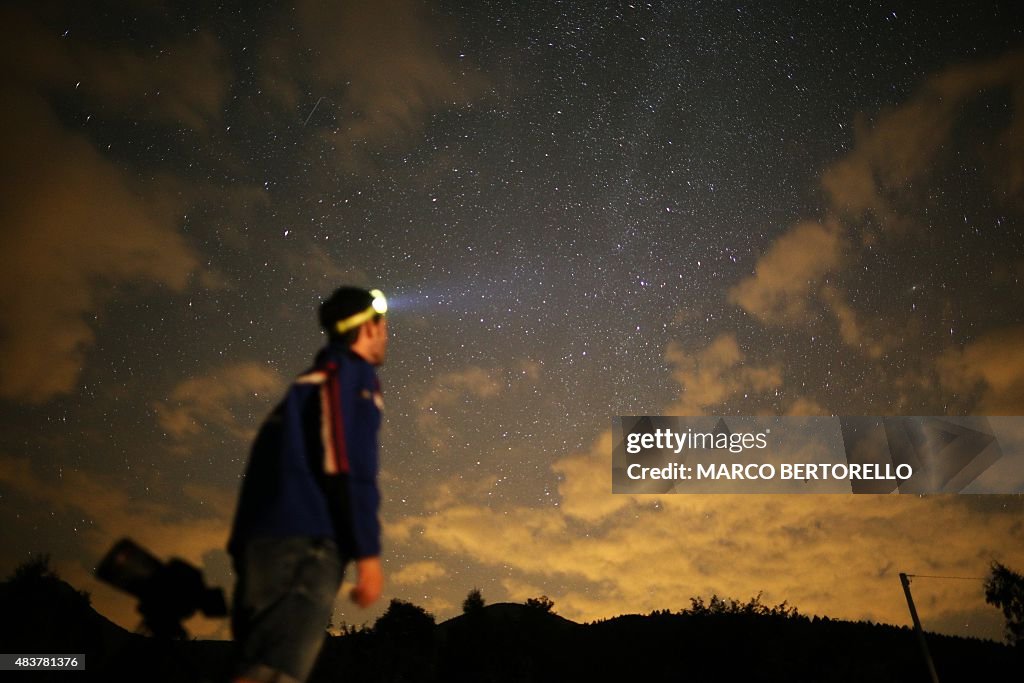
[[385, 444, 1024, 624]]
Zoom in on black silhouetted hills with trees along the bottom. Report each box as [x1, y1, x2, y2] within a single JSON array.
[[0, 568, 1024, 683]]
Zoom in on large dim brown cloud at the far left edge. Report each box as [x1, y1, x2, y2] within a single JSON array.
[[0, 88, 198, 403]]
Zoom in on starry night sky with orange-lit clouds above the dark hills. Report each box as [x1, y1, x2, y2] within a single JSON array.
[[0, 0, 1024, 638]]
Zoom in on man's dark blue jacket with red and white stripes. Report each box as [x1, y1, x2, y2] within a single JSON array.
[[227, 342, 383, 559]]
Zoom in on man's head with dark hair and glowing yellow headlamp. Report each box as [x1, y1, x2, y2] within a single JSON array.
[[319, 287, 387, 366]]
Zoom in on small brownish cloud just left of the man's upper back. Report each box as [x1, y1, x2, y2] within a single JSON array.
[[154, 362, 284, 441]]
